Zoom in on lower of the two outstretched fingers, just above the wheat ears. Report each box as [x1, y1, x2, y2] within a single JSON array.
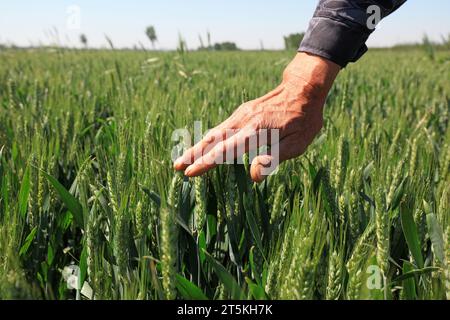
[[184, 127, 259, 177]]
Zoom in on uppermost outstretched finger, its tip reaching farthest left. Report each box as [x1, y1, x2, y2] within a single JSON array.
[[174, 121, 234, 171]]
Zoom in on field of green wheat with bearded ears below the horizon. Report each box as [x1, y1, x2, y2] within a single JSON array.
[[0, 48, 450, 300]]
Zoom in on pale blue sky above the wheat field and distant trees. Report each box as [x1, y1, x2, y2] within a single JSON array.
[[0, 0, 450, 49]]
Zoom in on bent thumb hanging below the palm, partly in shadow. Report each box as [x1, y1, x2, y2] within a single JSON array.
[[250, 135, 307, 183]]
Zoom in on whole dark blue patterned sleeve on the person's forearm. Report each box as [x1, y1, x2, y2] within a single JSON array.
[[299, 0, 406, 67]]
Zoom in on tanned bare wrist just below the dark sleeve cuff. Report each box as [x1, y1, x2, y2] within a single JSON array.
[[283, 52, 341, 99]]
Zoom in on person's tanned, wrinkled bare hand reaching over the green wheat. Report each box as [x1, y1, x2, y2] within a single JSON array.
[[174, 53, 340, 182]]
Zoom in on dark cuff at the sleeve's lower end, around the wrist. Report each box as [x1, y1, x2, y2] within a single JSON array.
[[298, 17, 370, 67]]
